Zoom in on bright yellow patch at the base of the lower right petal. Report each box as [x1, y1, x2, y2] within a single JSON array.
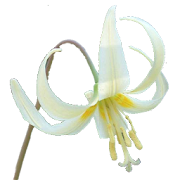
[[114, 93, 134, 108]]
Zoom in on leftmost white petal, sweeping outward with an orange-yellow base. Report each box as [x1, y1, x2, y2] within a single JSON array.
[[10, 79, 97, 135]]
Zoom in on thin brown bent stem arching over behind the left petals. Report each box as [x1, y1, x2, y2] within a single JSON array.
[[13, 39, 98, 180]]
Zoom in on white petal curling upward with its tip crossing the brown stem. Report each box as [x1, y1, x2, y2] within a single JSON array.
[[36, 49, 98, 120]]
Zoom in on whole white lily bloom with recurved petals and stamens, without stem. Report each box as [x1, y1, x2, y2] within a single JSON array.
[[10, 5, 169, 172]]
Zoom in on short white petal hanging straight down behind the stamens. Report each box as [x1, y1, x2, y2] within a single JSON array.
[[94, 103, 109, 139]]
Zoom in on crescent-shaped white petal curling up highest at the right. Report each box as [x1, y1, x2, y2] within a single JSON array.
[[120, 17, 166, 95]]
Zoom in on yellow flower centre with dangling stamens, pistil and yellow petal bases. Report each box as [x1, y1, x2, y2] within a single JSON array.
[[98, 97, 143, 172]]
